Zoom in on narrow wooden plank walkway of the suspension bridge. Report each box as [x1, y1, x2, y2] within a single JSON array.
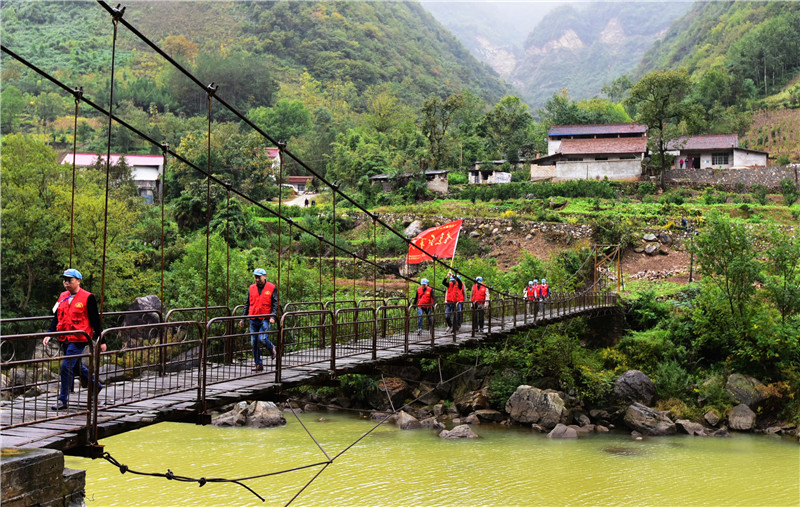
[[0, 306, 620, 451]]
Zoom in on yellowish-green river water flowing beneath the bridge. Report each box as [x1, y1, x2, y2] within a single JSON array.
[[66, 414, 800, 507]]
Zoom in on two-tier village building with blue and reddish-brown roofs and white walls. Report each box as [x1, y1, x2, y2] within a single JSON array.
[[531, 123, 647, 181]]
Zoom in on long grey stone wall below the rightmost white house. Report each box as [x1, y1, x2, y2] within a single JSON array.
[[664, 166, 798, 190]]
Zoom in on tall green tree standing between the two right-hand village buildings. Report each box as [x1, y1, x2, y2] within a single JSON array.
[[626, 69, 699, 188]]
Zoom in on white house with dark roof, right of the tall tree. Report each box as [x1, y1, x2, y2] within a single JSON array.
[[667, 134, 769, 169]]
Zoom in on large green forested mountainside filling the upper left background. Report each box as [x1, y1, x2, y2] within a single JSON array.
[[2, 1, 508, 110]]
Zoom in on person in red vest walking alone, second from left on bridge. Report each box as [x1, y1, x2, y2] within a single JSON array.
[[240, 268, 278, 371]]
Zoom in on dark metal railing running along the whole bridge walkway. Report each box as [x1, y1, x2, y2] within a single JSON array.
[[0, 291, 617, 444]]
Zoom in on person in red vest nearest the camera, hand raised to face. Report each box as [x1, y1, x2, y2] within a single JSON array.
[[42, 269, 106, 410]]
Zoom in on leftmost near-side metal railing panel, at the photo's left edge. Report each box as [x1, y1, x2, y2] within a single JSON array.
[[0, 331, 94, 434]]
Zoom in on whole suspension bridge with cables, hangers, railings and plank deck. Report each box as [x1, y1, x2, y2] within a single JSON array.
[[0, 1, 619, 457]]
